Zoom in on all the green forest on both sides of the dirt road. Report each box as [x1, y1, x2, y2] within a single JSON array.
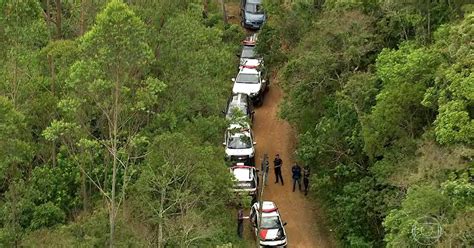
[[0, 0, 474, 247]]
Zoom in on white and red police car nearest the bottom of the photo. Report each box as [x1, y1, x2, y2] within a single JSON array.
[[250, 201, 287, 247]]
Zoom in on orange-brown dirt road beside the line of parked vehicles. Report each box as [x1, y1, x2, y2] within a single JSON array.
[[246, 82, 336, 248]]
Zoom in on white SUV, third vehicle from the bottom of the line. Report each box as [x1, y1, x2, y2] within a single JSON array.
[[222, 123, 257, 166]]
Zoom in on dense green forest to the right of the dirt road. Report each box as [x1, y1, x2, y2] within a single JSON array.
[[258, 0, 474, 247]]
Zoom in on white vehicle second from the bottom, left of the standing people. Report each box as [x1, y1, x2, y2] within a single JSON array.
[[230, 163, 258, 199]]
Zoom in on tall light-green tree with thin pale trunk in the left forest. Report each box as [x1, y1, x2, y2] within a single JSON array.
[[44, 1, 163, 247]]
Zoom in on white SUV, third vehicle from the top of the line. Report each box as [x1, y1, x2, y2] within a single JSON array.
[[232, 65, 268, 105]]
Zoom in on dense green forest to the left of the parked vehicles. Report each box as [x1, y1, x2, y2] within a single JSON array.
[[0, 0, 243, 247]]
